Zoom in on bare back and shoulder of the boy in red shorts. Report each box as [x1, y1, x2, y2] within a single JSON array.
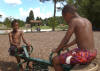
[[71, 17, 94, 50]]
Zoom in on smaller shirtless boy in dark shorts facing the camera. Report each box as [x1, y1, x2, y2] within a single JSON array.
[[9, 20, 30, 71]]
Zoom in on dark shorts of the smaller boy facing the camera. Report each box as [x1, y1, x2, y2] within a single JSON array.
[[8, 46, 23, 56]]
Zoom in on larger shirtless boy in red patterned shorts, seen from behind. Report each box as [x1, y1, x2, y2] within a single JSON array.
[[53, 5, 97, 71]]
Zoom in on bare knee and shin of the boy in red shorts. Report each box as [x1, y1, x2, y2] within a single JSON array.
[[53, 56, 63, 71]]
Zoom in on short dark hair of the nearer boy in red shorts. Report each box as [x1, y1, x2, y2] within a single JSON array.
[[62, 5, 76, 14]]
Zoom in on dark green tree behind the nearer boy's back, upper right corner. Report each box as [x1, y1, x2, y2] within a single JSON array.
[[78, 0, 100, 28]]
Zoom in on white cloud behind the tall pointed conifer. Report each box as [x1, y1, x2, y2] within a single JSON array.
[[19, 8, 52, 20]]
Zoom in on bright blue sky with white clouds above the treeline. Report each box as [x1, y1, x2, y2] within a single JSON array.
[[0, 0, 66, 21]]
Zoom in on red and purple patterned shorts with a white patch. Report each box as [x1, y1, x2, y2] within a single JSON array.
[[59, 48, 97, 64]]
